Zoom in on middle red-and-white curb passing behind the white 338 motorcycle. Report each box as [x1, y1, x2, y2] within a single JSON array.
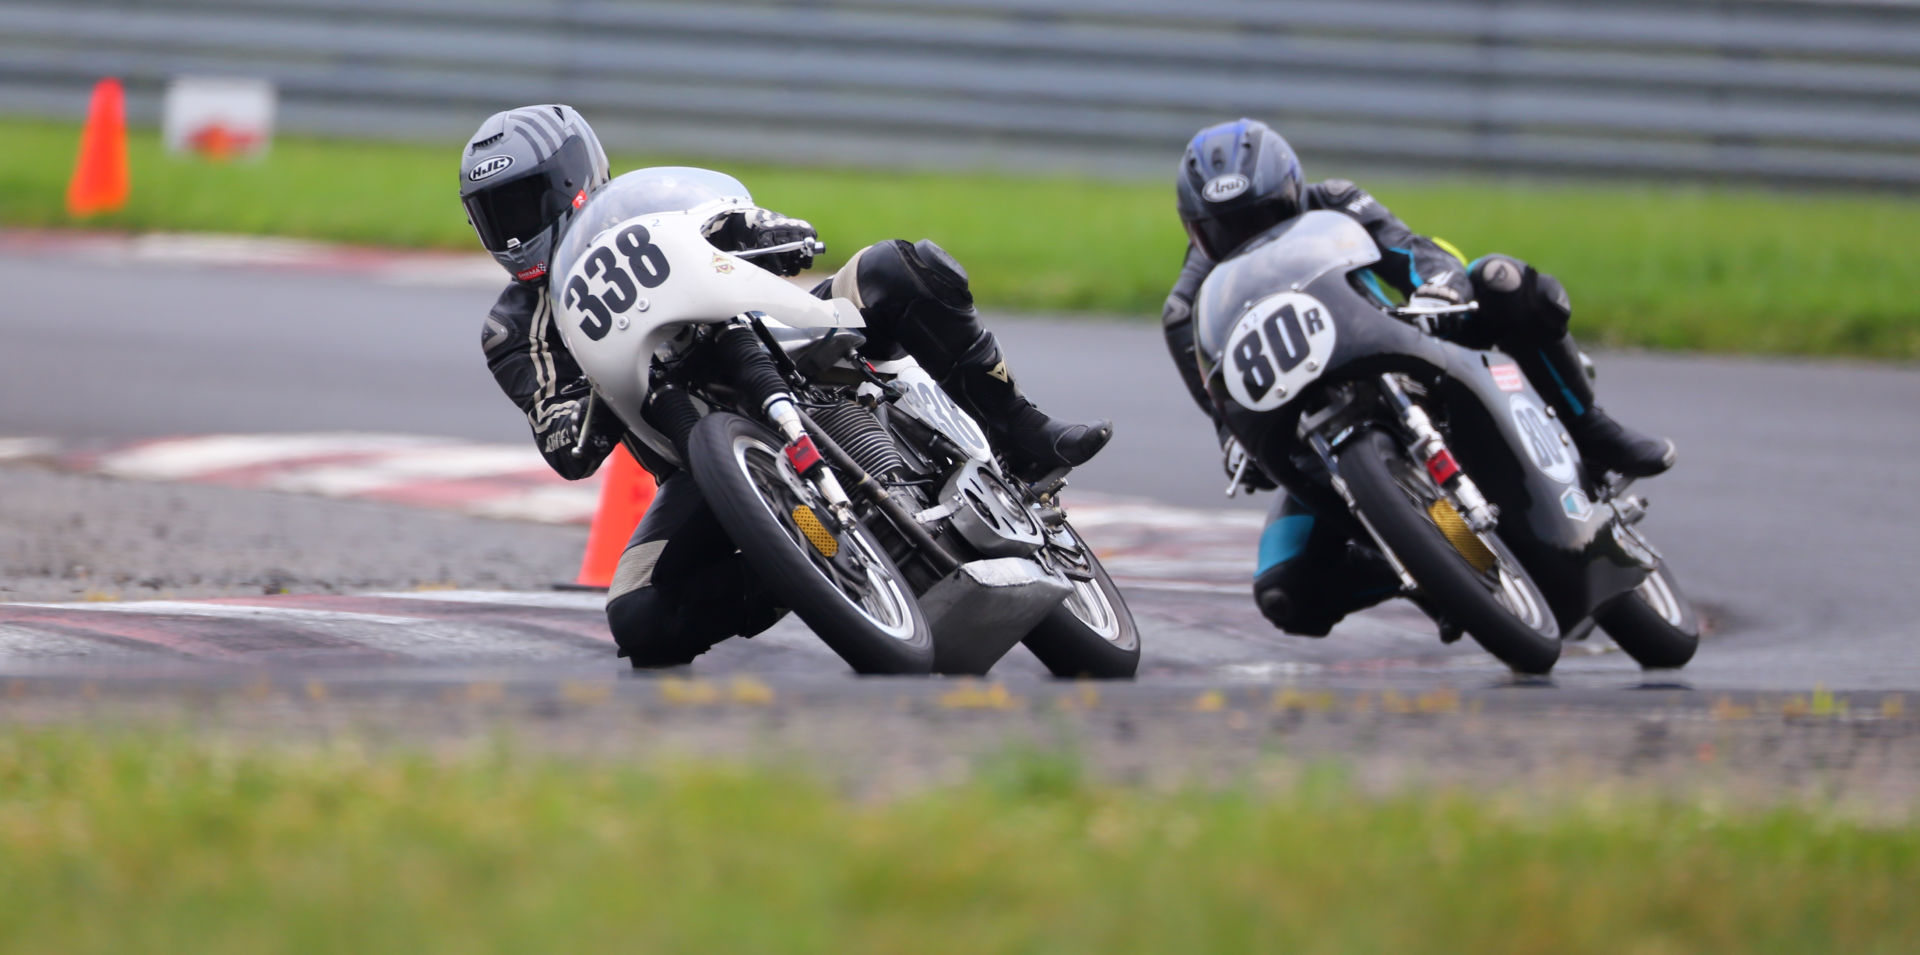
[[0, 432, 1261, 596]]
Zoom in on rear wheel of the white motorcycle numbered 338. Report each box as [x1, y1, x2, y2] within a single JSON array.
[[1023, 526, 1140, 680]]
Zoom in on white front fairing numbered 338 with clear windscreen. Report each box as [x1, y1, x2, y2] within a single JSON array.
[[547, 167, 866, 465]]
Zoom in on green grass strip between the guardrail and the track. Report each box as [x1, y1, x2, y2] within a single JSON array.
[[0, 121, 1920, 359]]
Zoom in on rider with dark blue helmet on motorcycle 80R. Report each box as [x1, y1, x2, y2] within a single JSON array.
[[1162, 119, 1674, 636]]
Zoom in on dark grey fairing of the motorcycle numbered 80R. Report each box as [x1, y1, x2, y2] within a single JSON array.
[[1194, 211, 1647, 628]]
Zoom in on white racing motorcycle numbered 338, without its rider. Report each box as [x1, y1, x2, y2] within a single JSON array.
[[549, 167, 1140, 678]]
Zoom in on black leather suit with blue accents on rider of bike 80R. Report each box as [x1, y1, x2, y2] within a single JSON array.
[[1162, 179, 1592, 636]]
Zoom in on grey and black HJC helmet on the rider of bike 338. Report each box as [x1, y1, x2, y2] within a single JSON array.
[[461, 104, 609, 282]]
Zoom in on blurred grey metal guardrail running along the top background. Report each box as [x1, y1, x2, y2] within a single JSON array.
[[0, 0, 1920, 186]]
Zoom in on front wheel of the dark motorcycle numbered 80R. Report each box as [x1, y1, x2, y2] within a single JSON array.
[[1334, 430, 1561, 673]]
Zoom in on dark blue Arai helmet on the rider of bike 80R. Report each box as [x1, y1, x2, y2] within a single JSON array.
[[1177, 119, 1306, 261]]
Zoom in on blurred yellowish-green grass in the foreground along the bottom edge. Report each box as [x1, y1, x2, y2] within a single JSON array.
[[0, 728, 1920, 955]]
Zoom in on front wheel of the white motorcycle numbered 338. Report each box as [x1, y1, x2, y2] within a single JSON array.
[[687, 411, 933, 674]]
